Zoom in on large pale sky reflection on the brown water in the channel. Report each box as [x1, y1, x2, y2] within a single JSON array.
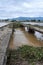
[[10, 29, 29, 48]]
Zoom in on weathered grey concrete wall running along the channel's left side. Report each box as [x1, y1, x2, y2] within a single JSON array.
[[0, 29, 12, 65]]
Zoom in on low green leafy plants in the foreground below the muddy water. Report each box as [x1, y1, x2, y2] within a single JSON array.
[[8, 45, 43, 65]]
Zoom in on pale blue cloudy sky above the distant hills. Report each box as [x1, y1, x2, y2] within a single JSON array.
[[0, 0, 43, 19]]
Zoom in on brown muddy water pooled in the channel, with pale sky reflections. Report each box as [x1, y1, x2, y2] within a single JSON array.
[[9, 28, 43, 49]]
